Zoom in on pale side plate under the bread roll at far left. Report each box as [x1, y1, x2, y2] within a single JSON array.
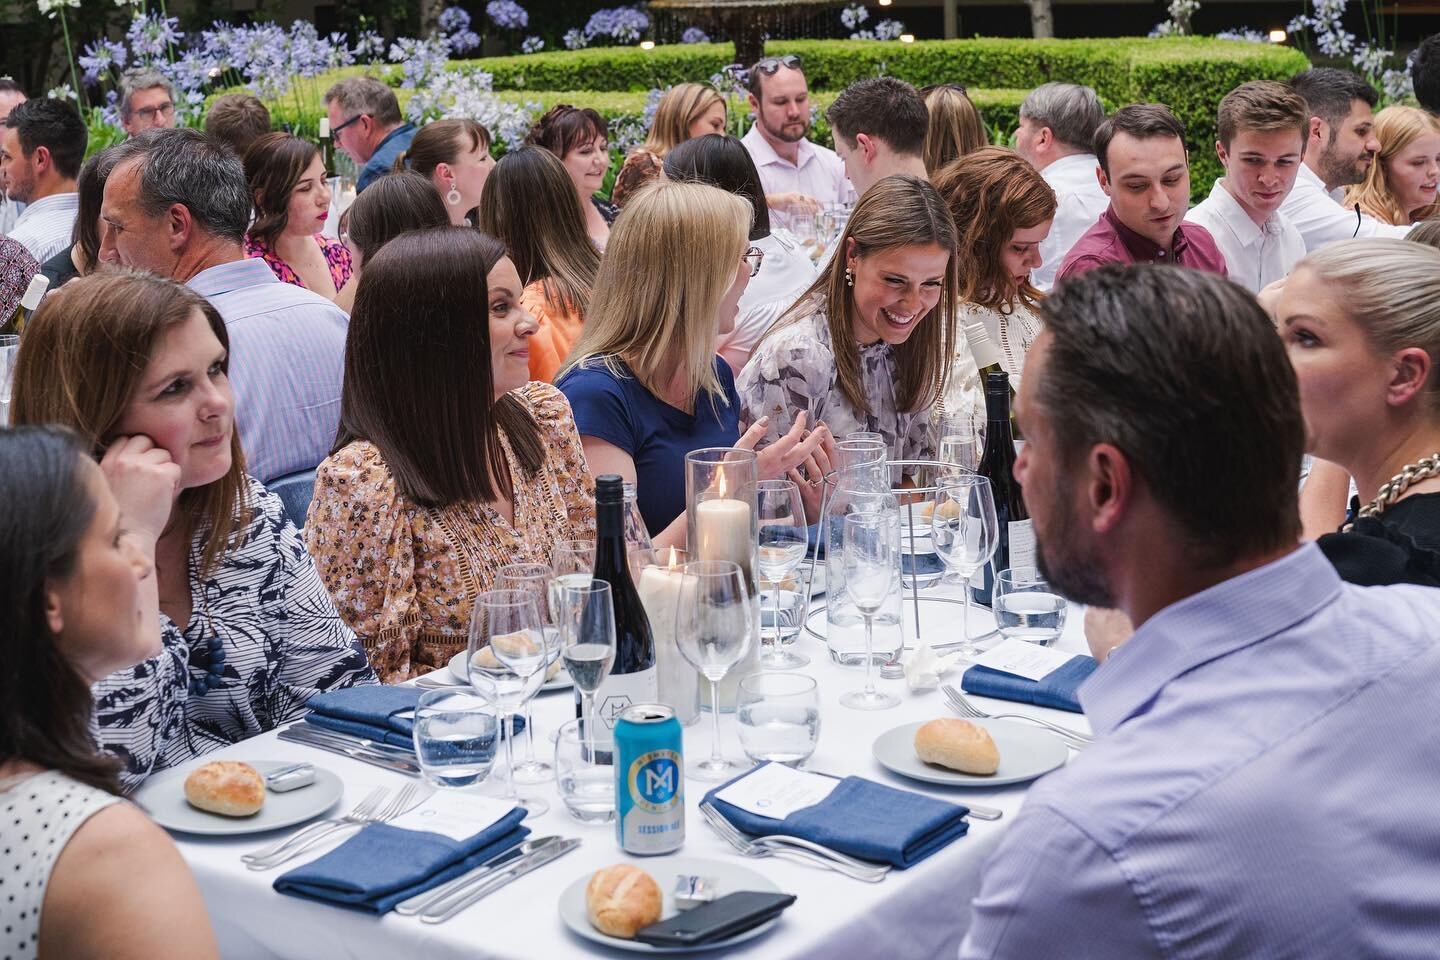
[[130, 757, 346, 836]]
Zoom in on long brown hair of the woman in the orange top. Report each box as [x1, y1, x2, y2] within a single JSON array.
[[480, 147, 600, 318]]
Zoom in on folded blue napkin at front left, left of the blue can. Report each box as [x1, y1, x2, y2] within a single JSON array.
[[275, 807, 530, 914]]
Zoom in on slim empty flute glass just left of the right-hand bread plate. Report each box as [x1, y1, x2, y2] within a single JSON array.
[[840, 510, 900, 710]]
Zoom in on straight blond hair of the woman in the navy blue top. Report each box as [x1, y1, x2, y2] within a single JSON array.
[[556, 180, 750, 409]]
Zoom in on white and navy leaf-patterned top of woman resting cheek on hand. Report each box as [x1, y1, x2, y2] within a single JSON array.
[[94, 478, 379, 790]]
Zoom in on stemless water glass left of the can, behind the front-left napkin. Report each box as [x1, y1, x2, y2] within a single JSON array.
[[413, 689, 501, 787]]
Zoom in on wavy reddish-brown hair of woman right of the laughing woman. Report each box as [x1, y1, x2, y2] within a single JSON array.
[[930, 147, 1056, 312]]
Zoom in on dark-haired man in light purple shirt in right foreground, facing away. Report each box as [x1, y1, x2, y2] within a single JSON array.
[[960, 260, 1440, 960]]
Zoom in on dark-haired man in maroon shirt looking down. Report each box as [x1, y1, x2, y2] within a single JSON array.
[[1056, 104, 1225, 282]]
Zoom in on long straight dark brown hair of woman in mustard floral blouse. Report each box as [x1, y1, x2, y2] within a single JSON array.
[[336, 228, 541, 507]]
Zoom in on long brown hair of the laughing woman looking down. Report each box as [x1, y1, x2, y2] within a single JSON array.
[[762, 174, 956, 412]]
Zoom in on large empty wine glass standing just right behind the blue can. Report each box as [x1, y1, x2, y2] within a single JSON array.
[[675, 560, 755, 780]]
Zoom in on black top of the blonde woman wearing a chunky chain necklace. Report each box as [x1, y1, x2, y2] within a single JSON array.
[[1318, 494, 1440, 587]]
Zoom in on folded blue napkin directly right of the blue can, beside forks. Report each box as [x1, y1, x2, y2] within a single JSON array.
[[706, 770, 971, 869]]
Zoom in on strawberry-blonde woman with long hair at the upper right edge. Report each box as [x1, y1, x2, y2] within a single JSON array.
[[1345, 107, 1440, 226]]
